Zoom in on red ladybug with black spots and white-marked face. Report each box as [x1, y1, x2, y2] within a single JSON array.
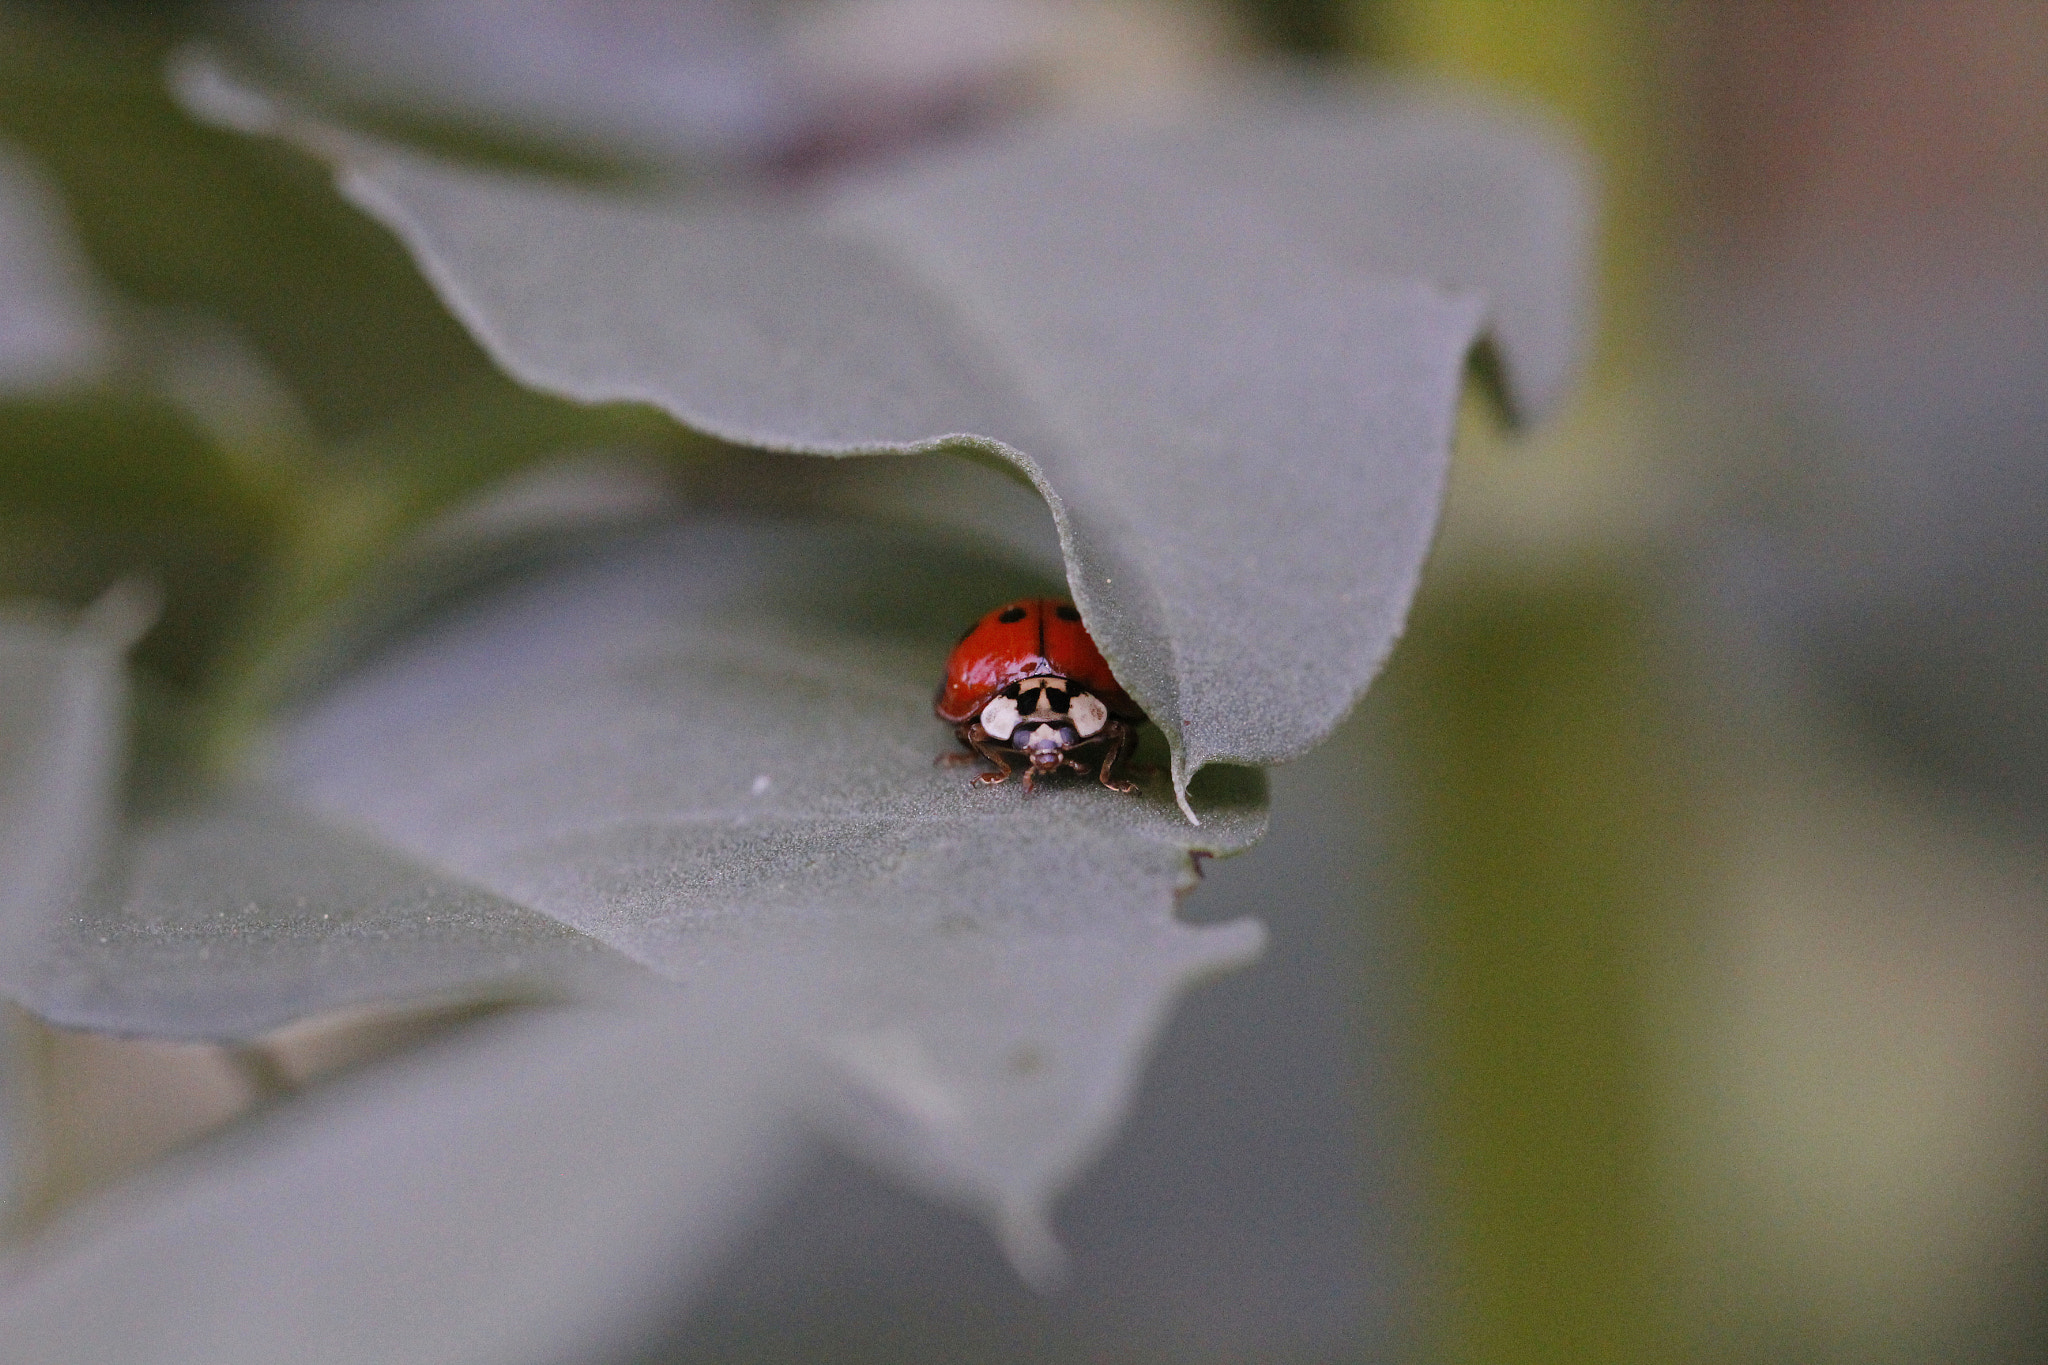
[[932, 598, 1145, 794]]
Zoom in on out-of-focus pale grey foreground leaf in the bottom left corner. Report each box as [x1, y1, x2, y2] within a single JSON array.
[[0, 972, 801, 1365]]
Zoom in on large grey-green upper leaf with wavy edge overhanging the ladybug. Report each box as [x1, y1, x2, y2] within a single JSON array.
[[180, 57, 1585, 810]]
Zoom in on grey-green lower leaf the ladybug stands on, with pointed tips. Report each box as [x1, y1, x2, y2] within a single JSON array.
[[6, 512, 1264, 1275]]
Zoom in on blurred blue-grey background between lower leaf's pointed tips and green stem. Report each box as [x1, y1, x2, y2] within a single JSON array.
[[671, 708, 1417, 1365]]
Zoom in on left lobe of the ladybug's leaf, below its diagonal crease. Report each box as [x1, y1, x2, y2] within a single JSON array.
[[0, 788, 631, 1038]]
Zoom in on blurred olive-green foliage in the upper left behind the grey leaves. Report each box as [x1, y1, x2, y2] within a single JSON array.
[[0, 4, 688, 732]]
